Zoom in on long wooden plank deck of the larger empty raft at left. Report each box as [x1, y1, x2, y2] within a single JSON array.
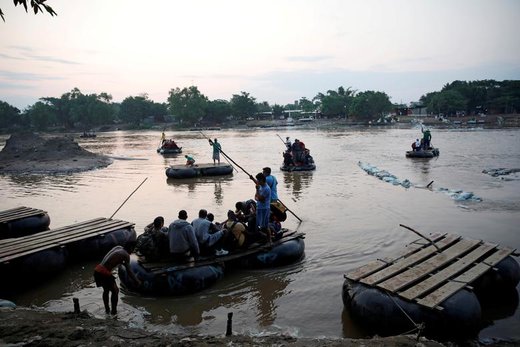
[[0, 218, 134, 264]]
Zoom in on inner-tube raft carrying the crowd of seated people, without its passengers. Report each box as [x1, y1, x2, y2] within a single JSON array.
[[119, 231, 305, 296]]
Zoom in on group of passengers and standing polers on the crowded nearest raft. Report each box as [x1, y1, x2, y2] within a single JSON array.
[[132, 167, 286, 263]]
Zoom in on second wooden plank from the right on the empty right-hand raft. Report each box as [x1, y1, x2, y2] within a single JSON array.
[[399, 243, 497, 300]]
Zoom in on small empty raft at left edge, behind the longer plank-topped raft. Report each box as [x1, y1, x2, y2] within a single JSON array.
[[0, 206, 51, 240]]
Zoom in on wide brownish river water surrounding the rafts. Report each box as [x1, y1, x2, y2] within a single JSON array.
[[0, 128, 520, 339]]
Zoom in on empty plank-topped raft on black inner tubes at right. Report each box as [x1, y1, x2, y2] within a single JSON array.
[[342, 234, 520, 339]]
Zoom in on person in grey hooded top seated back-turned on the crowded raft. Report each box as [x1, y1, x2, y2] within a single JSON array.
[[168, 210, 200, 262]]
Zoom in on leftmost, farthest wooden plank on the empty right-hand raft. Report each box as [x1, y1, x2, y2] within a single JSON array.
[[344, 234, 446, 281]]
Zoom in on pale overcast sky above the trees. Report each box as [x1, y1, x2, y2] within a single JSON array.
[[0, 0, 520, 110]]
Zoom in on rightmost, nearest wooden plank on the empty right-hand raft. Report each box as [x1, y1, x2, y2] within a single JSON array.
[[417, 248, 514, 308]]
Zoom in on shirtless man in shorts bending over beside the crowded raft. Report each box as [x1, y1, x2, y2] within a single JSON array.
[[94, 245, 141, 315]]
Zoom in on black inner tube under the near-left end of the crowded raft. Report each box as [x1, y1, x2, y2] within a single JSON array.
[[119, 257, 224, 296]]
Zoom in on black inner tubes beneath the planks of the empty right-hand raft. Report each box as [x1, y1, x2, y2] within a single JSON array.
[[342, 256, 520, 339]]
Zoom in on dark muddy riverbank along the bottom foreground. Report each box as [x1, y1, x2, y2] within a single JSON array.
[[0, 307, 445, 347]]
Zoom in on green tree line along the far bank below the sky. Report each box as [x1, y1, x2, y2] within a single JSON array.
[[0, 80, 520, 130]]
